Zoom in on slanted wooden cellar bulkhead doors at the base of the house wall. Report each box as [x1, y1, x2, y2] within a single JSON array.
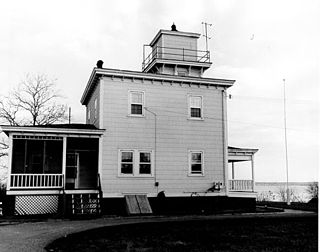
[[125, 195, 152, 215]]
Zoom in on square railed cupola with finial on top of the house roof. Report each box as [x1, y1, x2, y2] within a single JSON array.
[[142, 23, 211, 77]]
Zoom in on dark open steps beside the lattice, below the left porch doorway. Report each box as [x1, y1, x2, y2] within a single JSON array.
[[71, 193, 101, 216]]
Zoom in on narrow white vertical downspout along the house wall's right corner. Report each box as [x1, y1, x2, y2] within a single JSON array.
[[221, 90, 229, 196]]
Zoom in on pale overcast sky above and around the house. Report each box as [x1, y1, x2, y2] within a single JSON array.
[[0, 0, 320, 182]]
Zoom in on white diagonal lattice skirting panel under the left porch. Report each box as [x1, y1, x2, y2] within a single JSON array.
[[15, 195, 59, 215]]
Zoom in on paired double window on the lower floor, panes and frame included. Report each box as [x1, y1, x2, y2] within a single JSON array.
[[118, 150, 153, 177]]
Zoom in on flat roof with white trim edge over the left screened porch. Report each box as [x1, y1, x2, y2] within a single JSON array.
[[0, 124, 105, 137]]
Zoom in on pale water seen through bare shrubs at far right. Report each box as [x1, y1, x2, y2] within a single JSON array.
[[255, 182, 311, 202]]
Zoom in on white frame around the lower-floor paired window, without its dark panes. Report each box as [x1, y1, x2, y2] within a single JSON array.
[[118, 149, 154, 178]]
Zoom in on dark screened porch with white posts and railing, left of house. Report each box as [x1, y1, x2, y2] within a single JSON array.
[[2, 126, 105, 190]]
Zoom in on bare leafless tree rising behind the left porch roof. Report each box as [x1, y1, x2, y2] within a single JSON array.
[[0, 74, 67, 126]]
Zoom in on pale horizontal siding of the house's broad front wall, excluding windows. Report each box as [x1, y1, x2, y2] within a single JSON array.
[[101, 77, 224, 196]]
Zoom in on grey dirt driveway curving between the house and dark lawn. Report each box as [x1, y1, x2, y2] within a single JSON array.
[[0, 210, 317, 252]]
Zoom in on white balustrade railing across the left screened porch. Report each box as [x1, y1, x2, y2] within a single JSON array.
[[10, 174, 63, 189]]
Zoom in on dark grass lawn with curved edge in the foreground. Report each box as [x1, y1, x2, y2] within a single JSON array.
[[46, 216, 318, 252]]
